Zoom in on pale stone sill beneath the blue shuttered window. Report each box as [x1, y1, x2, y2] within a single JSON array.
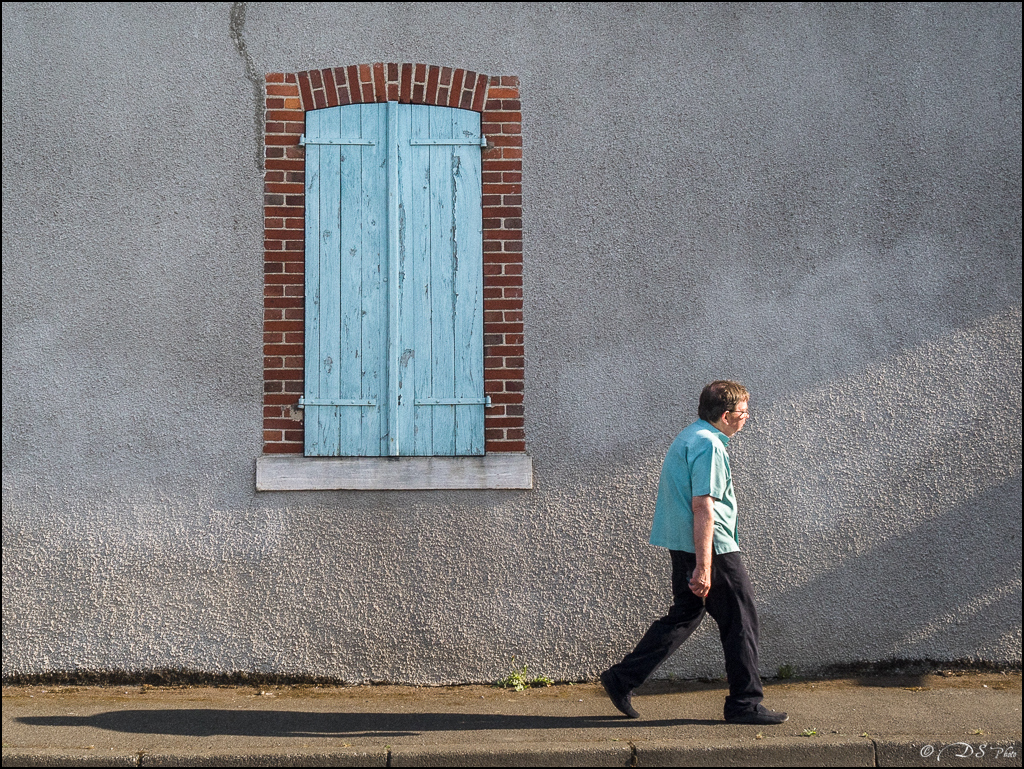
[[256, 454, 534, 492]]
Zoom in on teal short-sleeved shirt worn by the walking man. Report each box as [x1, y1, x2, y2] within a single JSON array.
[[650, 419, 739, 555]]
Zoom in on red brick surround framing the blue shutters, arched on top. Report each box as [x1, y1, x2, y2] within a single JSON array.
[[263, 63, 526, 454]]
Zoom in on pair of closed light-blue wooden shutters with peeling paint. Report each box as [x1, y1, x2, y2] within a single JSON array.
[[303, 102, 484, 456]]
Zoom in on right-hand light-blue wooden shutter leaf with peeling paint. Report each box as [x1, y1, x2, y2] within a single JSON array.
[[395, 104, 485, 456]]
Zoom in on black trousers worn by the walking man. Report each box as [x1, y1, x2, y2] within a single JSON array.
[[610, 550, 764, 718]]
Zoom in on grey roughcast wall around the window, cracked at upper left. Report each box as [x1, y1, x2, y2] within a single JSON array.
[[3, 3, 1021, 683]]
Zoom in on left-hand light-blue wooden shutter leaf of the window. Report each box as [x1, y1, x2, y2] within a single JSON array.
[[302, 104, 388, 457]]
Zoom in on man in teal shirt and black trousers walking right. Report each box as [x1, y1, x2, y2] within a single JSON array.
[[601, 380, 788, 725]]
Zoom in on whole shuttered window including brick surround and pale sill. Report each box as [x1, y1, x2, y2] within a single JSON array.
[[256, 62, 532, 490]]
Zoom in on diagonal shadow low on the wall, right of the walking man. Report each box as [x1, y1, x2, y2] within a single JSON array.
[[762, 475, 1021, 667]]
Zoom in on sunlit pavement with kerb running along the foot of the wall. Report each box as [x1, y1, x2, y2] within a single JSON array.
[[3, 673, 1021, 766]]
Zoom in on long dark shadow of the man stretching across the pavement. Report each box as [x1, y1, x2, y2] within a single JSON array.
[[14, 709, 724, 737]]
